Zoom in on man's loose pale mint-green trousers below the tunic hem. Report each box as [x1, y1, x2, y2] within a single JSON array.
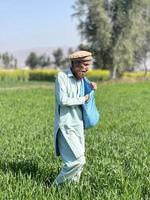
[[53, 129, 85, 185]]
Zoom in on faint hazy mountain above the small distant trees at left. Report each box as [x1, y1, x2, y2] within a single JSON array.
[[1, 46, 75, 68]]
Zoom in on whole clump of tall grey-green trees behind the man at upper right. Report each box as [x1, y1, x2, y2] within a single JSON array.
[[73, 0, 150, 78]]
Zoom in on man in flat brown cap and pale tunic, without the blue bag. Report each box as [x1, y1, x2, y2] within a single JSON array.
[[54, 51, 97, 185]]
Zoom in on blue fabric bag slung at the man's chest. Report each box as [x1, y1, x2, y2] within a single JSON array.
[[80, 78, 100, 129]]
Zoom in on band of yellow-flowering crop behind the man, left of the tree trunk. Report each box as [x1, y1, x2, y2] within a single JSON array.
[[0, 69, 109, 83]]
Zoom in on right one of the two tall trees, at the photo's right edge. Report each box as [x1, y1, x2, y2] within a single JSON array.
[[112, 0, 150, 78]]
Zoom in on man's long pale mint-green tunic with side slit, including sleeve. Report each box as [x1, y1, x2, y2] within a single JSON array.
[[54, 69, 85, 158]]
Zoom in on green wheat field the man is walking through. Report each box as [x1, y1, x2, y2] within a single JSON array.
[[0, 82, 150, 200]]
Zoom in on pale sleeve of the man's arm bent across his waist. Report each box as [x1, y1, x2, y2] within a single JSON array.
[[55, 73, 85, 106]]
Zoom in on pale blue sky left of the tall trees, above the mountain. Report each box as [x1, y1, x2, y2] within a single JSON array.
[[0, 0, 80, 50]]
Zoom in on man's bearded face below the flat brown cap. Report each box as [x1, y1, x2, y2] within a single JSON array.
[[73, 61, 91, 80]]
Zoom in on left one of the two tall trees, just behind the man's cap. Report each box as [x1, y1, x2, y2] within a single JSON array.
[[74, 0, 111, 68]]
